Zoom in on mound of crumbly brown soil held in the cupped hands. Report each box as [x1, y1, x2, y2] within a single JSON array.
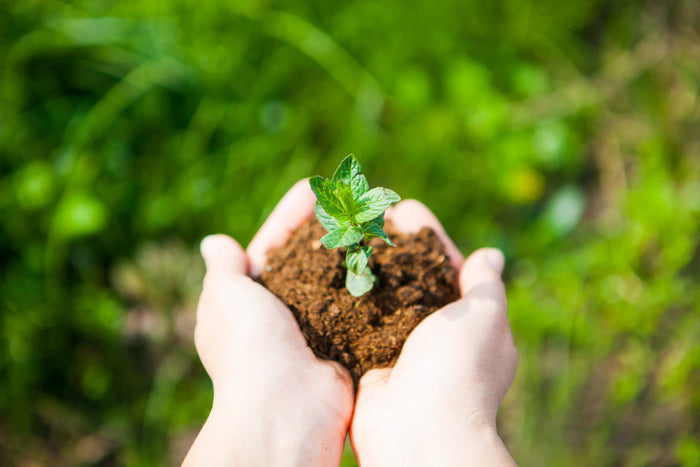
[[260, 219, 458, 386]]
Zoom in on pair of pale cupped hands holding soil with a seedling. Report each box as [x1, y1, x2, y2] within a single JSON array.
[[184, 180, 518, 466]]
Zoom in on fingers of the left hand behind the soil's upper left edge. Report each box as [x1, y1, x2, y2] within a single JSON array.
[[247, 178, 316, 277]]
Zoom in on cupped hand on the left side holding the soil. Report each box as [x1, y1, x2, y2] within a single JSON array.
[[184, 181, 353, 466]]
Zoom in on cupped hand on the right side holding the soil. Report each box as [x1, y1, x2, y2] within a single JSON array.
[[351, 202, 518, 467]]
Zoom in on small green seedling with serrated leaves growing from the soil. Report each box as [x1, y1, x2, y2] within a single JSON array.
[[310, 154, 401, 297]]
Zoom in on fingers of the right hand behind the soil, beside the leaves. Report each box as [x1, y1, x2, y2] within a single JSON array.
[[386, 199, 464, 270]]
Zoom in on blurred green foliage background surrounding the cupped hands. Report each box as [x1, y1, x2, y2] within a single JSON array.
[[0, 0, 700, 466]]
